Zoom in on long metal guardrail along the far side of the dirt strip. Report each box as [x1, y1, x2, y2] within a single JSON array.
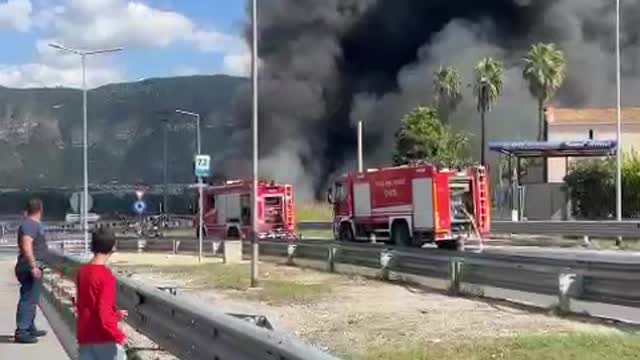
[[105, 239, 640, 311]]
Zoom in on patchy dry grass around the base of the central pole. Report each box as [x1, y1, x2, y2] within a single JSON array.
[[144, 264, 333, 305]]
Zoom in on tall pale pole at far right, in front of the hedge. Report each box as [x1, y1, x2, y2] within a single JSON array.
[[616, 0, 622, 245]]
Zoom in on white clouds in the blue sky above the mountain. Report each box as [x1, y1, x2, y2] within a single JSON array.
[[0, 0, 248, 87]]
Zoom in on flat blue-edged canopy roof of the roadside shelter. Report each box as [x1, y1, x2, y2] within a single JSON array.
[[489, 140, 618, 157]]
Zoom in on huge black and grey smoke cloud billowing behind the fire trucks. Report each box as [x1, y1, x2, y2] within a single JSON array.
[[232, 0, 640, 198]]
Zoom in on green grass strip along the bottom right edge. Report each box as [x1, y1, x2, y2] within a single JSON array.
[[358, 334, 640, 360]]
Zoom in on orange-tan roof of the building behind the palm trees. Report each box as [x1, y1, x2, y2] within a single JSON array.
[[545, 107, 640, 126]]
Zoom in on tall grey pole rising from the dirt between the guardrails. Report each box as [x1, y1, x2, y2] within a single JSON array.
[[251, 0, 259, 287]]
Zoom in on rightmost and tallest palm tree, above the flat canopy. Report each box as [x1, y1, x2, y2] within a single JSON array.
[[522, 43, 567, 141]]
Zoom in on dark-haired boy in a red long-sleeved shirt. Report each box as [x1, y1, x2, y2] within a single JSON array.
[[76, 228, 127, 360]]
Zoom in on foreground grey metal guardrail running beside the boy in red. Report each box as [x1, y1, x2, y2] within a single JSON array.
[[48, 251, 337, 360]]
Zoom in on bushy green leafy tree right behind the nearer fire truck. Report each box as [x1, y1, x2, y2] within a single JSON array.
[[393, 107, 470, 168]]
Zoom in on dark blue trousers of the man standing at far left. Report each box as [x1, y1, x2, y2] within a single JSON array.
[[16, 270, 41, 336]]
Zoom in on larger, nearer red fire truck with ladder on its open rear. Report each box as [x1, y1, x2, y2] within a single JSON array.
[[328, 165, 491, 249]]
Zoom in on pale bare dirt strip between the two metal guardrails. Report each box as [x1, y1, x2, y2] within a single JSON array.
[[109, 254, 617, 357]]
